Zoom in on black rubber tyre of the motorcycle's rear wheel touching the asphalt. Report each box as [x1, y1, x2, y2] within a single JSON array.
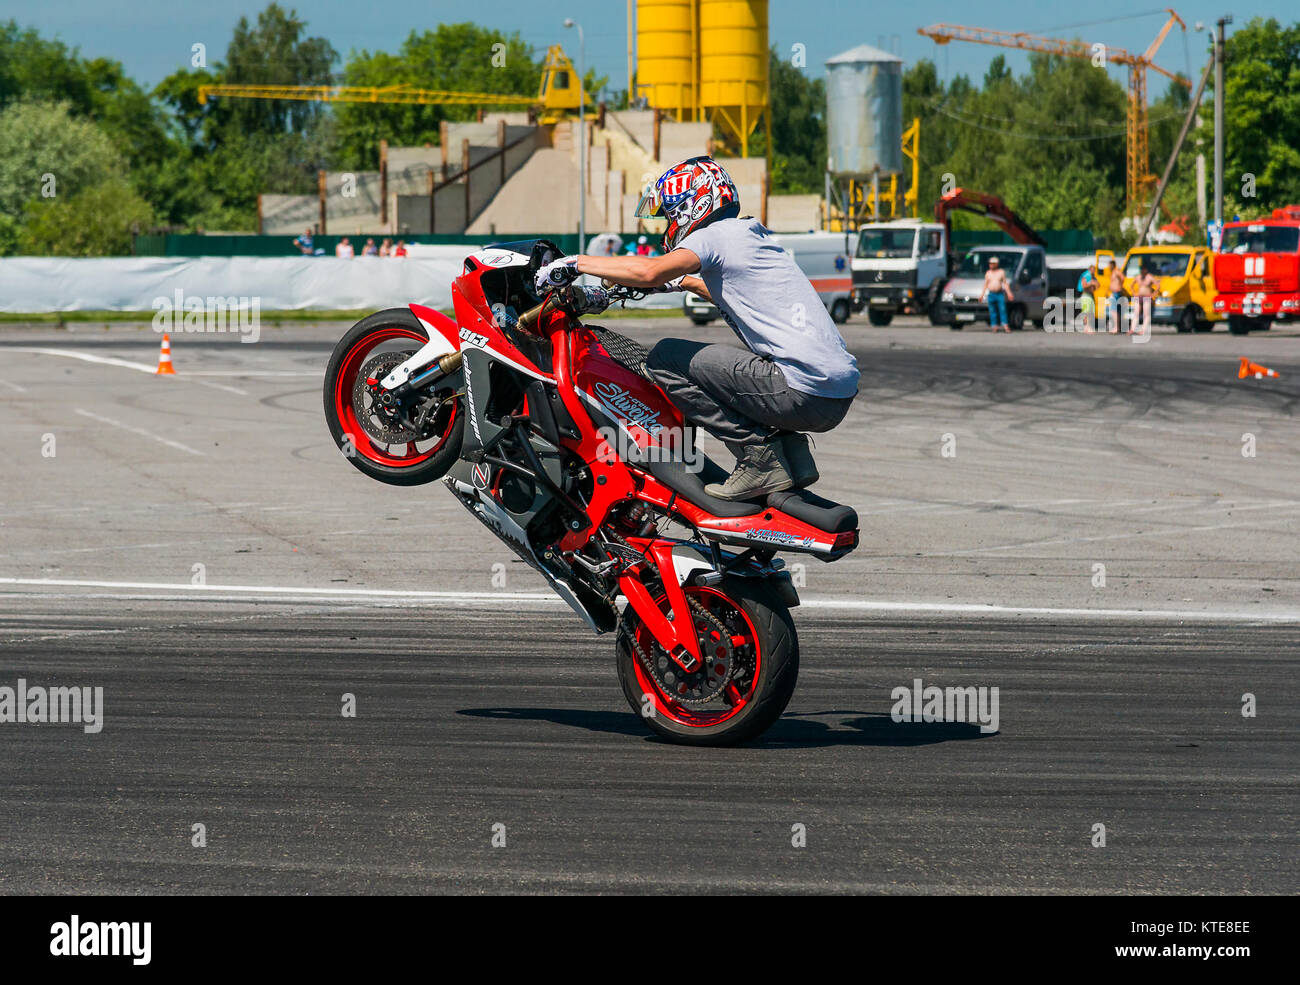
[[616, 577, 800, 746]]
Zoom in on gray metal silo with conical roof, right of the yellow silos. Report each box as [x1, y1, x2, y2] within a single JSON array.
[[826, 44, 902, 181]]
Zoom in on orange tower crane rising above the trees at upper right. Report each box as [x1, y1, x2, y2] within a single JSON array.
[[917, 6, 1192, 216]]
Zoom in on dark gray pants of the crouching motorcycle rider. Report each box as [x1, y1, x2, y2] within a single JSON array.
[[646, 339, 853, 444]]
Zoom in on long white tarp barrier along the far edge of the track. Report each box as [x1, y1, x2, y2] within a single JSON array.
[[0, 252, 681, 314]]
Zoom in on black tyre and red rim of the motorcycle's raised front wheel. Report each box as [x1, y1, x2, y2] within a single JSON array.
[[322, 308, 465, 486]]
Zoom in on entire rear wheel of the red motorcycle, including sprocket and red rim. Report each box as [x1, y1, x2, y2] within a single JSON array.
[[616, 577, 800, 746]]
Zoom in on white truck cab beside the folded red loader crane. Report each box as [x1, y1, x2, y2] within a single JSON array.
[[853, 218, 949, 325]]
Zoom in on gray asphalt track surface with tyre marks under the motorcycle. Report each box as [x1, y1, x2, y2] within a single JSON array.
[[0, 318, 1300, 893]]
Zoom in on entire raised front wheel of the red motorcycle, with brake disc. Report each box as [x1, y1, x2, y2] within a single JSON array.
[[322, 308, 465, 486]]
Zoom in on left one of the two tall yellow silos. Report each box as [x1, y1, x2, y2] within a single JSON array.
[[636, 0, 698, 120]]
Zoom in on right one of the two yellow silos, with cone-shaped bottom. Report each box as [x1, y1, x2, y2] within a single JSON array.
[[698, 0, 768, 157]]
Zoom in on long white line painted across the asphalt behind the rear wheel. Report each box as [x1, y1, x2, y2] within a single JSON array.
[[0, 577, 1300, 622]]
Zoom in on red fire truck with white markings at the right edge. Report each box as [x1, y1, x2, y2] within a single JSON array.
[[1214, 205, 1300, 335]]
